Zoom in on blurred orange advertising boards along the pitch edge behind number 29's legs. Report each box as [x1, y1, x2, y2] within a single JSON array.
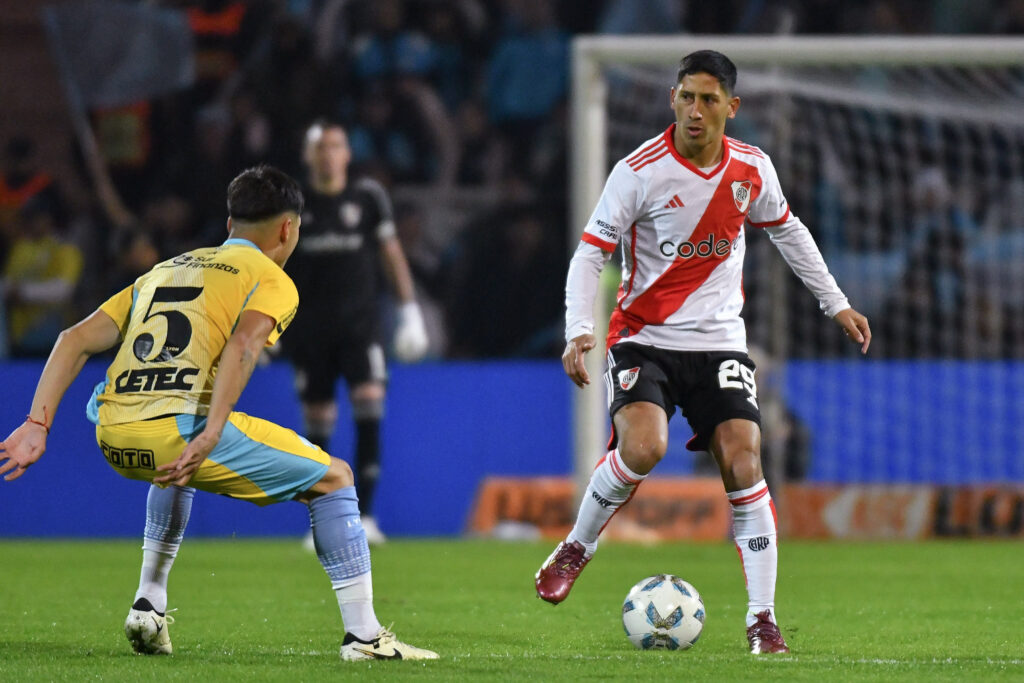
[[469, 477, 1024, 543]]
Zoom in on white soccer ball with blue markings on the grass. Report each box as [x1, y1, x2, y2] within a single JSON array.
[[623, 573, 705, 650]]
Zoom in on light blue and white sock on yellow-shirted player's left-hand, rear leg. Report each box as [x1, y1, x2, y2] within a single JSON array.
[[135, 485, 196, 612]]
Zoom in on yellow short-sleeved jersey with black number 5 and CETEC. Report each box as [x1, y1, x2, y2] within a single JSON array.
[[89, 239, 299, 425]]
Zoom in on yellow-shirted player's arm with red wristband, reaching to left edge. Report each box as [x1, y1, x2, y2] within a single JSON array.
[[0, 310, 121, 481]]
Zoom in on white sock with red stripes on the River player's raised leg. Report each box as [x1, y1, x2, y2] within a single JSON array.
[[566, 449, 647, 556]]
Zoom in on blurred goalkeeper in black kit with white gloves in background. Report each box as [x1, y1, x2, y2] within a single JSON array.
[[285, 121, 428, 543]]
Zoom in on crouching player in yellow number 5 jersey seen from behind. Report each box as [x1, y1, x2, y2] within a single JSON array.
[[0, 166, 437, 660]]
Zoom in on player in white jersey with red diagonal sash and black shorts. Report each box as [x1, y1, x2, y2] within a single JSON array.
[[536, 50, 871, 654]]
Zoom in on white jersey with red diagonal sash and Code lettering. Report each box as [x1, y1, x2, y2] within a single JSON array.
[[583, 124, 790, 351]]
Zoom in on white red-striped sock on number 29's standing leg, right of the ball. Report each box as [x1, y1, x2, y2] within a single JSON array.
[[727, 479, 778, 626]]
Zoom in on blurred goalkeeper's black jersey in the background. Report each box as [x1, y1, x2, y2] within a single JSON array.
[[287, 178, 395, 332]]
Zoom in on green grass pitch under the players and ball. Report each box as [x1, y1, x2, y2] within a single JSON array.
[[0, 539, 1024, 682]]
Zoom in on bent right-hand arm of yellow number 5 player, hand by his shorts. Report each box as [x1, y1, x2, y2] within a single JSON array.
[[153, 310, 275, 486]]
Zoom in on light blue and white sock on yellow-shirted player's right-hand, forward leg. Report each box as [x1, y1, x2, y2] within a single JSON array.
[[309, 486, 381, 640]]
